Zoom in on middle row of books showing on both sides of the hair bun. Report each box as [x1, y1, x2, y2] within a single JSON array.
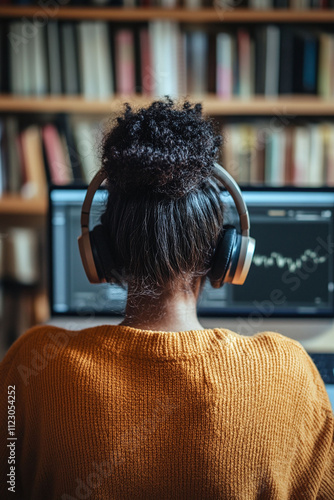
[[0, 117, 334, 197]]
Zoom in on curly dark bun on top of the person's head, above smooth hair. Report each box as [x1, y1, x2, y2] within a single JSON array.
[[102, 98, 221, 198]]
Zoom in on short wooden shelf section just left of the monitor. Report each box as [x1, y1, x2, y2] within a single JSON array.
[[0, 194, 47, 216]]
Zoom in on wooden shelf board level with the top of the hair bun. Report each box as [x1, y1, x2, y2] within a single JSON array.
[[0, 95, 334, 116]]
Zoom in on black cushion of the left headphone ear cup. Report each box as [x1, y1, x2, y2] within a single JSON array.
[[89, 224, 121, 283]]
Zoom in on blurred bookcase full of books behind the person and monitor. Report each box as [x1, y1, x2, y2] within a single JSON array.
[[0, 0, 334, 358]]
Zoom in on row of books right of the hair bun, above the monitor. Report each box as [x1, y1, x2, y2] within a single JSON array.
[[222, 120, 334, 187]]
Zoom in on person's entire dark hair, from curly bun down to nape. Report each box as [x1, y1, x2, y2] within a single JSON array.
[[101, 96, 223, 291]]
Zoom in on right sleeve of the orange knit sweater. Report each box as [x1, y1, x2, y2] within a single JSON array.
[[292, 345, 334, 500]]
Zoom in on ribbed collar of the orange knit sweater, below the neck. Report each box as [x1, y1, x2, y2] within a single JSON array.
[[87, 325, 237, 359]]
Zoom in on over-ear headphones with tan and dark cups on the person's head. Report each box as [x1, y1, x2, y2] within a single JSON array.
[[78, 163, 255, 288]]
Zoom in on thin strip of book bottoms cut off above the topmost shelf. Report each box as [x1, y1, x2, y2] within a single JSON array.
[[0, 0, 334, 9]]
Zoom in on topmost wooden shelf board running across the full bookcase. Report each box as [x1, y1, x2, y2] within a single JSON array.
[[0, 5, 334, 23]]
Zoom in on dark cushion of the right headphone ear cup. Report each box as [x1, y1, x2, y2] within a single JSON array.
[[208, 225, 237, 288]]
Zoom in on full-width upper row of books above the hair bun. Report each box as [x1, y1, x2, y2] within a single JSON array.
[[0, 20, 334, 100]]
